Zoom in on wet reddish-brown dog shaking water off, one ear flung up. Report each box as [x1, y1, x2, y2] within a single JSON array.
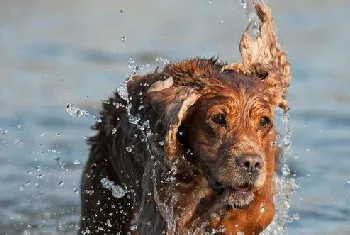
[[80, 3, 290, 235]]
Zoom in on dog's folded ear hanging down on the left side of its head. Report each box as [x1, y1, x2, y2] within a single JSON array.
[[148, 77, 202, 160]]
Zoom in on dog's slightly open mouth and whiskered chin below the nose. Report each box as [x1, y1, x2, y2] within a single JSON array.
[[209, 180, 254, 208]]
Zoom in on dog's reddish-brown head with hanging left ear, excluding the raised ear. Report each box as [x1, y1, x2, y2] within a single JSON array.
[[149, 65, 281, 207]]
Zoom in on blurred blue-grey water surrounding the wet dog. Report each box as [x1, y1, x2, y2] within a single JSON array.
[[0, 0, 350, 235]]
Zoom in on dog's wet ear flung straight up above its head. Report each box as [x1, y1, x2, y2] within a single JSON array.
[[223, 1, 291, 110]]
